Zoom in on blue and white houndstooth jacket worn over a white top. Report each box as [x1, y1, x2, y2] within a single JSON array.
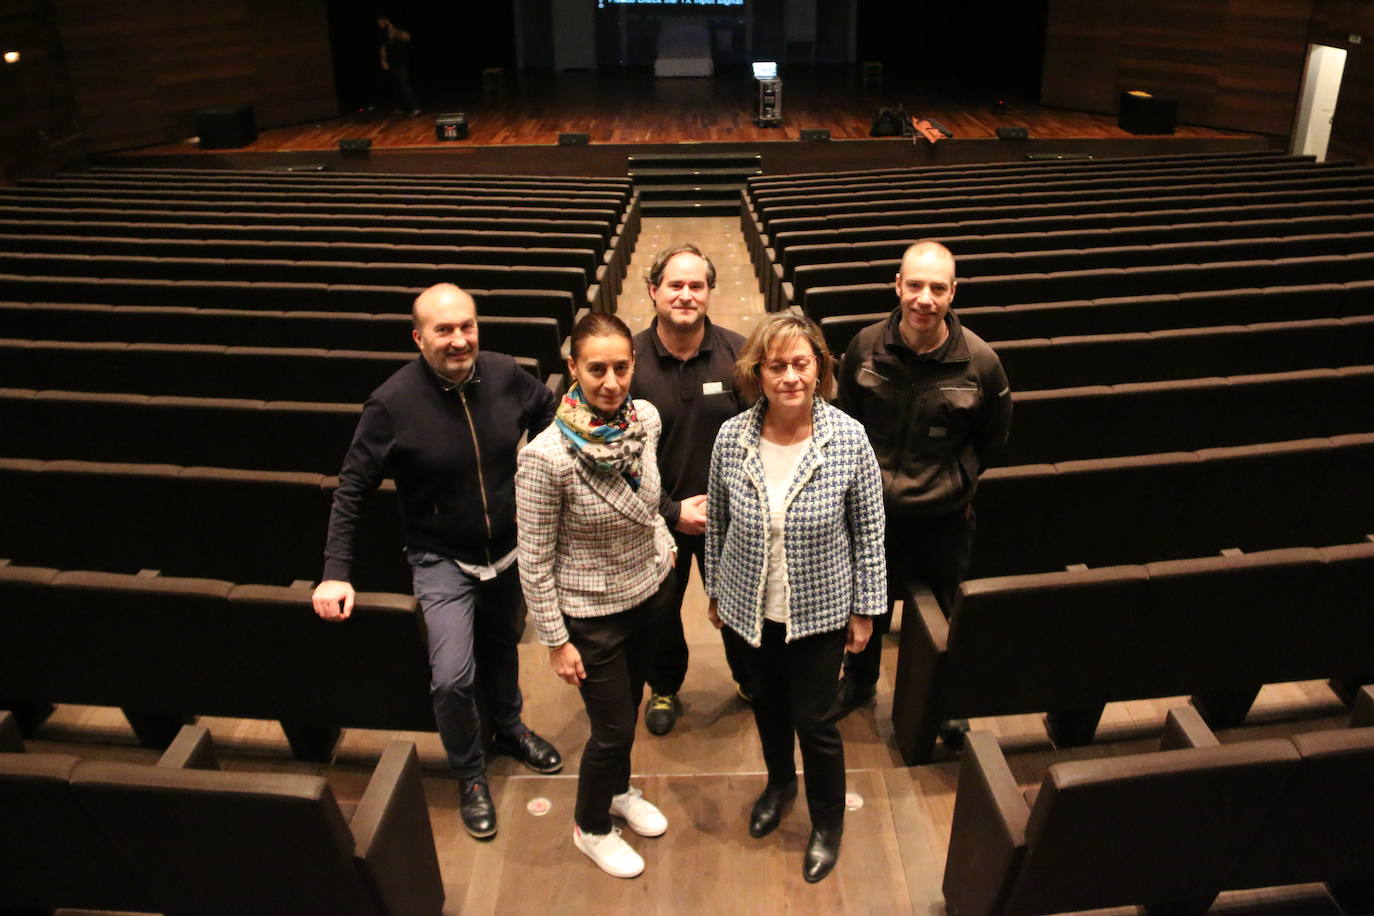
[[706, 398, 888, 645]]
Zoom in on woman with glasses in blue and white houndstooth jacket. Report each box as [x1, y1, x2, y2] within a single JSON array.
[[706, 313, 886, 882]]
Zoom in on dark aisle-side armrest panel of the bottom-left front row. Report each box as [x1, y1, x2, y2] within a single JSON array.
[[349, 742, 444, 916]]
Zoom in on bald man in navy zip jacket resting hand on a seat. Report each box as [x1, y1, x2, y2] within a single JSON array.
[[313, 283, 563, 838]]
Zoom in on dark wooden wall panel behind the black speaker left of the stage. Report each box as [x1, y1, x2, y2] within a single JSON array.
[[55, 0, 338, 151]]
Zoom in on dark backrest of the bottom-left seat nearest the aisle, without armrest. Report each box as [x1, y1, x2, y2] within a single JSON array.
[[71, 761, 379, 916]]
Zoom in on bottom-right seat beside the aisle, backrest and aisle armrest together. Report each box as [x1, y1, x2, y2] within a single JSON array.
[[943, 732, 1301, 916]]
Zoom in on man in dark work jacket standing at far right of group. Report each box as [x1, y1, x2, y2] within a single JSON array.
[[838, 240, 1011, 744]]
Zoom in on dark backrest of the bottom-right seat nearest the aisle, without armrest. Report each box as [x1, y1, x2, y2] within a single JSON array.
[[1003, 739, 1298, 913]]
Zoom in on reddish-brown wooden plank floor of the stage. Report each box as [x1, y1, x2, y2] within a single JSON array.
[[120, 67, 1257, 155]]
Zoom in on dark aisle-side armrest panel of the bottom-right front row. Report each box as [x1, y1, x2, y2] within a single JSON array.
[[943, 732, 1031, 916]]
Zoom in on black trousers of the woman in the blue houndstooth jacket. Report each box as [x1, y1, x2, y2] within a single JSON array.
[[721, 621, 846, 829]]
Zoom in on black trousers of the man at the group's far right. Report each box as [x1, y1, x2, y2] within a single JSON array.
[[845, 507, 977, 685]]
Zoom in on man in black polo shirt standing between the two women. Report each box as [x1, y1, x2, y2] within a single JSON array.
[[631, 244, 749, 735]]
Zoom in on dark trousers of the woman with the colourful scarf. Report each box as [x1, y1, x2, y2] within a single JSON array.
[[563, 570, 673, 834]]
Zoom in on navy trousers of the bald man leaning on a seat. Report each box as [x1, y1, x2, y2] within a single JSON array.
[[407, 551, 525, 779]]
